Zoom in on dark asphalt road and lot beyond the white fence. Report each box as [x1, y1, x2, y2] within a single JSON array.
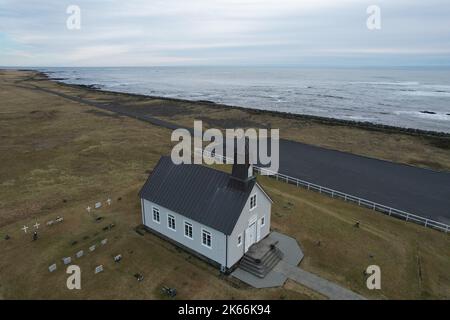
[[26, 86, 450, 224]]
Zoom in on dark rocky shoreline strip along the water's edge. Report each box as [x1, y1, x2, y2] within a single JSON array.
[[34, 69, 450, 138]]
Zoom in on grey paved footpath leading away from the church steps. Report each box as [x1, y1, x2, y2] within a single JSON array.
[[274, 261, 366, 300]]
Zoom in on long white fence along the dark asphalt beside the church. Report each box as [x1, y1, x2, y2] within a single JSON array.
[[195, 149, 450, 233]]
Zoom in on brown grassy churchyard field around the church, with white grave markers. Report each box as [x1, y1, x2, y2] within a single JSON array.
[[0, 71, 450, 299]]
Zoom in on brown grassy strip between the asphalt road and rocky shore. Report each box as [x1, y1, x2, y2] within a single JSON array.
[[4, 70, 450, 172]]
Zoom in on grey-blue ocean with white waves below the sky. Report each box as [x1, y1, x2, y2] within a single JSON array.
[[38, 67, 450, 133]]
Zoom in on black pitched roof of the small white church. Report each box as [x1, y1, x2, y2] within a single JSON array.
[[139, 157, 256, 235]]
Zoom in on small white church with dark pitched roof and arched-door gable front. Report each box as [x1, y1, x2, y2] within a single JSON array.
[[139, 157, 272, 272]]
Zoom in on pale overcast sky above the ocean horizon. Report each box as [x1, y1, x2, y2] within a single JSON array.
[[0, 0, 450, 66]]
